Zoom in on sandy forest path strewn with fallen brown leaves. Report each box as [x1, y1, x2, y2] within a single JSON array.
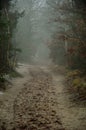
[[0, 65, 86, 130]]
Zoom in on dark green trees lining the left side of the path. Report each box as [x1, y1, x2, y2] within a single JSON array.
[[0, 5, 21, 86]]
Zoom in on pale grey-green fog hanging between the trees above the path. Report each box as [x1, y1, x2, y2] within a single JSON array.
[[10, 0, 61, 64]]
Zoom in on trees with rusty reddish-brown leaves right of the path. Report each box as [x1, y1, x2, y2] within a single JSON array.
[[49, 1, 86, 72]]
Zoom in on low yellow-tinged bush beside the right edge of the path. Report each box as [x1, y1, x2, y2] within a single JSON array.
[[66, 70, 86, 99]]
